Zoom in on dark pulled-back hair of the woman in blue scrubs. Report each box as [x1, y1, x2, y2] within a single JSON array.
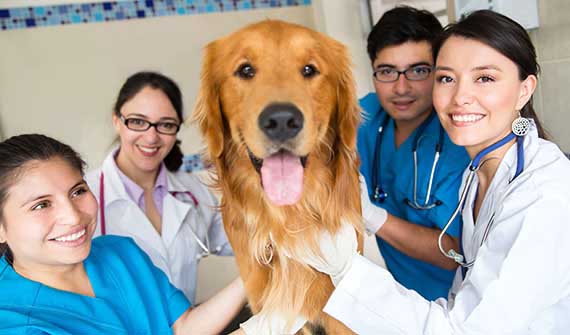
[[0, 134, 85, 262]]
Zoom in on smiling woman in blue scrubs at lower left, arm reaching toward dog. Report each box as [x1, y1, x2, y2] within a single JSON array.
[[0, 135, 245, 334]]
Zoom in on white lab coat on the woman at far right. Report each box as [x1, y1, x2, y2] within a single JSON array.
[[325, 127, 570, 335]]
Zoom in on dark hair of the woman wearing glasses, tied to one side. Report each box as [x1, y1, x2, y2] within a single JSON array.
[[113, 71, 184, 172]]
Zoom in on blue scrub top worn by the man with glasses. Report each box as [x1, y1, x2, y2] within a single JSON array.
[[357, 93, 470, 300]]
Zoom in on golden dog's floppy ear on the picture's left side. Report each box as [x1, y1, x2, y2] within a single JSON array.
[[192, 42, 224, 159]]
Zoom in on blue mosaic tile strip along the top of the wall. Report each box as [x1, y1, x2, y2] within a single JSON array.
[[0, 0, 311, 30]]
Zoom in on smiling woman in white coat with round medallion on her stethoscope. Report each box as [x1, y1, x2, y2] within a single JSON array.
[[291, 10, 570, 335]]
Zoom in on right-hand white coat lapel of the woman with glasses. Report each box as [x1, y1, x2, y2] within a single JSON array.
[[162, 172, 194, 247]]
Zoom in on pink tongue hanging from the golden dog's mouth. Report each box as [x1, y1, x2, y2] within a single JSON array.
[[261, 152, 303, 206]]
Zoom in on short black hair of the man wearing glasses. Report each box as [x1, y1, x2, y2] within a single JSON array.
[[367, 6, 443, 62]]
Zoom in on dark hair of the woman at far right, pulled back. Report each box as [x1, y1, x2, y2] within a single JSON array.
[[433, 10, 549, 139]]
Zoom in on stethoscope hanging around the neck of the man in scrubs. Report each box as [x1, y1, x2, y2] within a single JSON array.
[[371, 112, 444, 210]]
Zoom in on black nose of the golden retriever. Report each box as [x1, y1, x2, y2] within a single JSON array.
[[259, 103, 304, 142]]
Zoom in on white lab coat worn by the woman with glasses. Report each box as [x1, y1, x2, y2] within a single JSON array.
[[85, 151, 232, 303]]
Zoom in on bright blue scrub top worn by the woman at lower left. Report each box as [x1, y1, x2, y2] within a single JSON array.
[[0, 235, 191, 335]]
